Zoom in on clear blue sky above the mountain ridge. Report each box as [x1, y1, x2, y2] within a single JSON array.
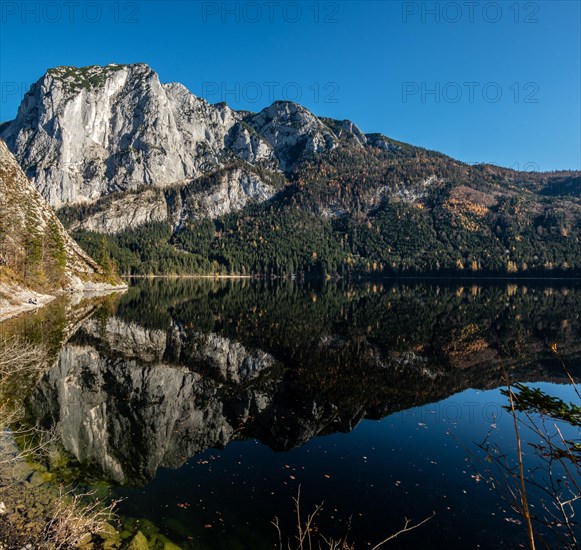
[[0, 0, 581, 170]]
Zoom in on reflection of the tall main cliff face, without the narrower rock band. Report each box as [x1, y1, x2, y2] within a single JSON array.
[[32, 345, 278, 482]]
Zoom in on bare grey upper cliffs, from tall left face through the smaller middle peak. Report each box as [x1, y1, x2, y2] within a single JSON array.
[[0, 64, 360, 210]]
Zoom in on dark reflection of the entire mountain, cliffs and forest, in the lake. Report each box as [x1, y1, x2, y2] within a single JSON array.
[[29, 285, 580, 483]]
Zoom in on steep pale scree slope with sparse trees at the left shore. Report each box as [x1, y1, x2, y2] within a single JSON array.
[[0, 141, 124, 318]]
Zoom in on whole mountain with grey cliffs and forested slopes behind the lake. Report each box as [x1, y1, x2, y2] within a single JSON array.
[[0, 64, 581, 276]]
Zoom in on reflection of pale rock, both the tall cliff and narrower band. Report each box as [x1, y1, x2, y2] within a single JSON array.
[[30, 317, 277, 483]]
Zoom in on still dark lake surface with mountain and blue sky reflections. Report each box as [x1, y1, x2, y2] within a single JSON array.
[[12, 280, 581, 549]]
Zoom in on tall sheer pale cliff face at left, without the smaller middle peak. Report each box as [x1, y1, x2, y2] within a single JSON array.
[[1, 64, 236, 207]]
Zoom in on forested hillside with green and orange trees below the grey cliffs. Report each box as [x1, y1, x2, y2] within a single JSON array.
[[63, 142, 581, 276]]
